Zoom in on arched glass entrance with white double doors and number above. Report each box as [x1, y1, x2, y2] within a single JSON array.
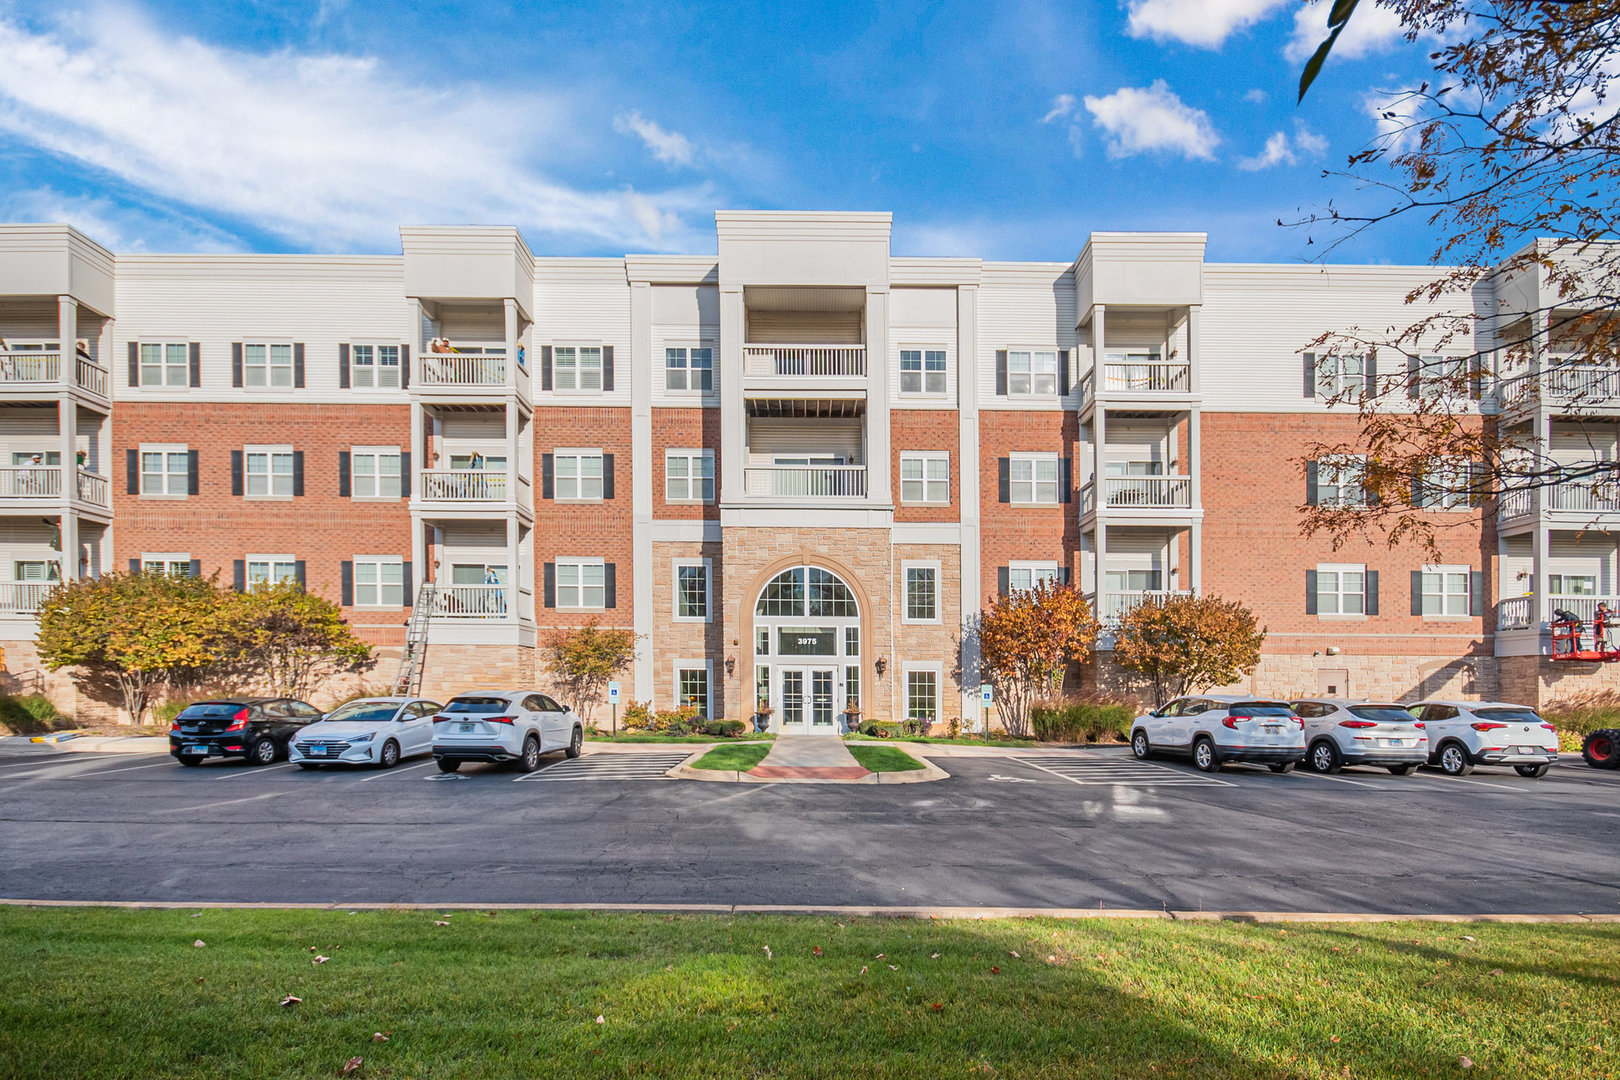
[[753, 563, 862, 735]]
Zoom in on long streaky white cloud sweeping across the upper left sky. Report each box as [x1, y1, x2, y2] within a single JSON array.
[[0, 8, 710, 249]]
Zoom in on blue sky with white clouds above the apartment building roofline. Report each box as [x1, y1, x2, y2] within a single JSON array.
[[0, 0, 1432, 262]]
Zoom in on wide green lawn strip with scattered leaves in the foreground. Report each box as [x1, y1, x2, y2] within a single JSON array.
[[0, 908, 1620, 1080]]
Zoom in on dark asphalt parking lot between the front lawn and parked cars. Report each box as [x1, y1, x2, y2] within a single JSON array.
[[0, 746, 1620, 913]]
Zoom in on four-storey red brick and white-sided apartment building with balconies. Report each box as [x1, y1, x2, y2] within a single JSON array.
[[0, 212, 1620, 730]]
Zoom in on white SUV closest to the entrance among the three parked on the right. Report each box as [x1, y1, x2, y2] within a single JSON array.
[[1131, 693, 1306, 772]]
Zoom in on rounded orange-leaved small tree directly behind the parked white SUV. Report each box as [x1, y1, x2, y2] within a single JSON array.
[[1115, 596, 1265, 706]]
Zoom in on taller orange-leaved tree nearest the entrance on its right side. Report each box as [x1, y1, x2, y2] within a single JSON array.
[[978, 581, 1097, 738]]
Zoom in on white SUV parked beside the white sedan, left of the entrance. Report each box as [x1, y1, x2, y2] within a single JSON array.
[[433, 690, 585, 772]]
